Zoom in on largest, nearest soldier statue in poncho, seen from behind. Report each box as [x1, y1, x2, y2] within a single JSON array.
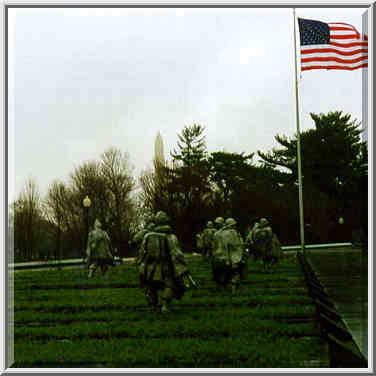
[[136, 211, 195, 313]]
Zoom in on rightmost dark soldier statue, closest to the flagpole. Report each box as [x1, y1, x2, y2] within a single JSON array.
[[253, 218, 282, 271]]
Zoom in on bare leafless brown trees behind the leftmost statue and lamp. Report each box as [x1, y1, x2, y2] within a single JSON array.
[[10, 148, 137, 260]]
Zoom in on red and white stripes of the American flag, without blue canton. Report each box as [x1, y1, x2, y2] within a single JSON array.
[[300, 22, 368, 71]]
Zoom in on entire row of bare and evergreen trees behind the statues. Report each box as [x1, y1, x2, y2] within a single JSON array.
[[10, 111, 368, 259]]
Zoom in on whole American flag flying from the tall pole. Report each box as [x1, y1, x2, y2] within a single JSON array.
[[298, 18, 368, 71]]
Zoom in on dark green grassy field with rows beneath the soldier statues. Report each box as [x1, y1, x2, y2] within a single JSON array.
[[13, 256, 328, 368]]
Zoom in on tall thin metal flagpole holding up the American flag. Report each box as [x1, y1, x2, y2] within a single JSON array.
[[293, 8, 305, 253]]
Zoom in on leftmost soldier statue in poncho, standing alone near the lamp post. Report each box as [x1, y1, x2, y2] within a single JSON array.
[[86, 219, 114, 278]]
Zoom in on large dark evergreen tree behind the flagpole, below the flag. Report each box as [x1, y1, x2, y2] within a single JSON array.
[[258, 111, 368, 242]]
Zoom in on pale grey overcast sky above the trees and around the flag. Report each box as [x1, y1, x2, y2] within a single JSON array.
[[8, 8, 365, 200]]
